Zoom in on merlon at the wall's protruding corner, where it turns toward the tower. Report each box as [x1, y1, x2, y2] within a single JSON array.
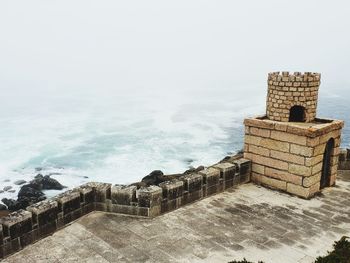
[[136, 185, 163, 208]]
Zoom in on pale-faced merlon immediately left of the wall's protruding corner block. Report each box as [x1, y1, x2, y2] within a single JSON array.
[[111, 185, 137, 205]]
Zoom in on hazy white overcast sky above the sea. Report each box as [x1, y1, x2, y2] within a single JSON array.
[[0, 0, 350, 98]]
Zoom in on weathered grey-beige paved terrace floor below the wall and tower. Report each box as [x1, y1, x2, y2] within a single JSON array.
[[4, 173, 350, 263]]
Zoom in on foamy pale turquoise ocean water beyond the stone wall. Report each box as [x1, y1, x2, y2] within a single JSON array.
[[0, 87, 350, 198]]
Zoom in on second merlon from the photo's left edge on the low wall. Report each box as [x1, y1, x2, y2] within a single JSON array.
[[27, 200, 58, 227]]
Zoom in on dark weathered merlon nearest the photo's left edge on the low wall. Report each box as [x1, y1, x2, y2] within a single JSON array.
[[0, 209, 33, 239]]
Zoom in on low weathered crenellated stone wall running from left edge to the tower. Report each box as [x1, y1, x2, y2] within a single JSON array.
[[0, 157, 251, 260]]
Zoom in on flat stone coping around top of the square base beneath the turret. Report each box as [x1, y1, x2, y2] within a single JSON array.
[[244, 115, 344, 138]]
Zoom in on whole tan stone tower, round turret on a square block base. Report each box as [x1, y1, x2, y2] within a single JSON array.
[[244, 72, 344, 198]]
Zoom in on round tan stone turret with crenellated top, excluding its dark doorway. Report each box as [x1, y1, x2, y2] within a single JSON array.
[[266, 72, 321, 122]]
